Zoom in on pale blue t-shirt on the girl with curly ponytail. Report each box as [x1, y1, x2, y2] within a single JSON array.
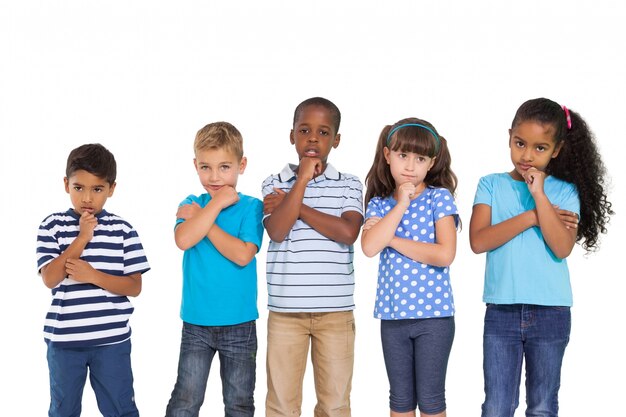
[[474, 173, 580, 306]]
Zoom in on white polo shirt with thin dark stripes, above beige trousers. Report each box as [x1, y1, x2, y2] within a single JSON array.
[[262, 164, 363, 313]]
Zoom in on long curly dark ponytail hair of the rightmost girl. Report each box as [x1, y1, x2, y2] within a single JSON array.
[[511, 98, 615, 252]]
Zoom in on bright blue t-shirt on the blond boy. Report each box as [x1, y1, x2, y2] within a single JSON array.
[[176, 193, 263, 326]]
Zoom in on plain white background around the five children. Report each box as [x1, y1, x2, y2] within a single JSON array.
[[0, 0, 626, 417]]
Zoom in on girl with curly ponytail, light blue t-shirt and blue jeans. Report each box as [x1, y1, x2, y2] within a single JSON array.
[[470, 98, 613, 417]]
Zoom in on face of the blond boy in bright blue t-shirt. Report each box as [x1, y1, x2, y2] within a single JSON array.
[[193, 148, 247, 197]]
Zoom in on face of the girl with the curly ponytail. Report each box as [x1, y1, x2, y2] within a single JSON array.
[[509, 121, 563, 181]]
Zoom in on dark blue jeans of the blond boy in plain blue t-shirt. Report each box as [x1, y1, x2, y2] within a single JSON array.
[[165, 321, 257, 417]]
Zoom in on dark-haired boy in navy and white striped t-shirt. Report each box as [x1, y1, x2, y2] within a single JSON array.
[[37, 144, 150, 416]]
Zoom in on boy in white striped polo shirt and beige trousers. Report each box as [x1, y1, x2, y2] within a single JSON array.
[[263, 97, 363, 417]]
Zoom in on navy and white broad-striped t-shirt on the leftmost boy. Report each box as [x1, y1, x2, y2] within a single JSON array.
[[37, 209, 150, 348]]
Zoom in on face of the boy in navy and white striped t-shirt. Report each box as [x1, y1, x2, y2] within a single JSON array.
[[63, 169, 115, 216]]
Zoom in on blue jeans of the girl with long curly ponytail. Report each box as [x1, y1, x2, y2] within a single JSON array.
[[482, 304, 571, 417]]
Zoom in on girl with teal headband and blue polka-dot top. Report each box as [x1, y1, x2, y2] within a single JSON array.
[[361, 118, 459, 416]]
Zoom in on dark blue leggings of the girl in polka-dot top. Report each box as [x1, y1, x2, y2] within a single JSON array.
[[380, 317, 455, 414]]
